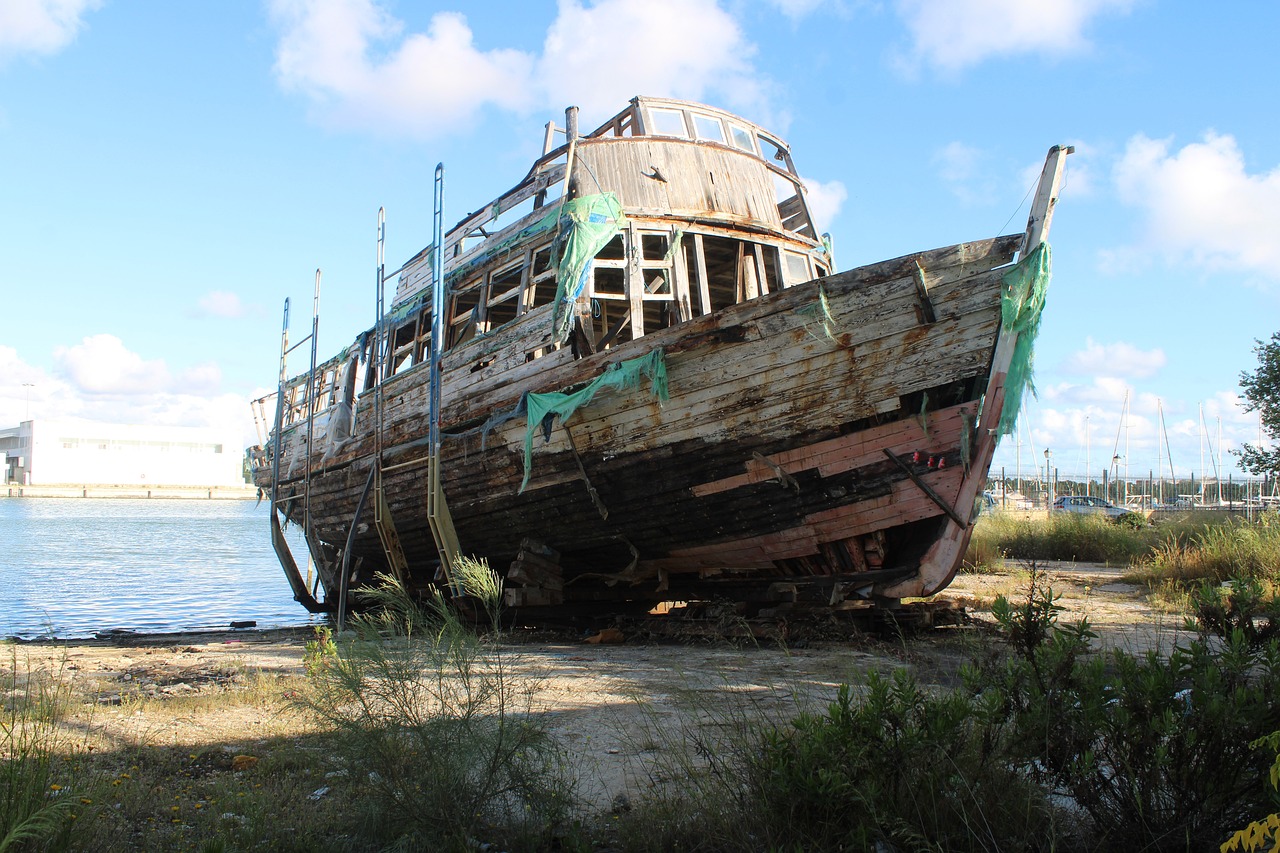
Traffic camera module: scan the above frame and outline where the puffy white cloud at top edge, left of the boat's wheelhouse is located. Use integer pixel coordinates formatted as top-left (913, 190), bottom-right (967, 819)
top-left (271, 0), bottom-right (532, 137)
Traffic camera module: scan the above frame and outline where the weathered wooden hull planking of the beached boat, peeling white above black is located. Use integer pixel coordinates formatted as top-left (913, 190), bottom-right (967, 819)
top-left (267, 238), bottom-right (1019, 594)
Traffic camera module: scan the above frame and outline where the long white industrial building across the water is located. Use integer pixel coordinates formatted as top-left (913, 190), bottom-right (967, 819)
top-left (0, 419), bottom-right (244, 487)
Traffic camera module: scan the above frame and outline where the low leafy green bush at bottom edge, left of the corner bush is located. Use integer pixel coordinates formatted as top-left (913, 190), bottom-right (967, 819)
top-left (744, 670), bottom-right (1053, 850)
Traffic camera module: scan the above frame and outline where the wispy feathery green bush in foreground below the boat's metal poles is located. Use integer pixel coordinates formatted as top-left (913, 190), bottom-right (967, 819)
top-left (308, 560), bottom-right (573, 849)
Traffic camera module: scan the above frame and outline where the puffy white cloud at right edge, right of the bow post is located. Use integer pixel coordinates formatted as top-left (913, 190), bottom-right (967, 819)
top-left (1105, 132), bottom-right (1280, 279)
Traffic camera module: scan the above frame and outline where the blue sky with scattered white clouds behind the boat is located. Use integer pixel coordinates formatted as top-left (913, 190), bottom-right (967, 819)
top-left (0, 0), bottom-right (1280, 476)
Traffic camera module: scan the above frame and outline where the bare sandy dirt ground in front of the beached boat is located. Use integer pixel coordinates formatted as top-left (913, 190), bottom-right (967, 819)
top-left (0, 564), bottom-right (1189, 806)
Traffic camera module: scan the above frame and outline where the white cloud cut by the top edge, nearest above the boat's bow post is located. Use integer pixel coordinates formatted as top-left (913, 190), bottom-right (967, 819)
top-left (896, 0), bottom-right (1134, 72)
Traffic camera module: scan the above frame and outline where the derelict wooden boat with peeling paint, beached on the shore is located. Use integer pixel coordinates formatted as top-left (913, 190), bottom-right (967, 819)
top-left (255, 97), bottom-right (1070, 612)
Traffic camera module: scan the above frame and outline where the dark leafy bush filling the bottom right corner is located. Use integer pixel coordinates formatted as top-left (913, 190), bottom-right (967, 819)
top-left (966, 560), bottom-right (1280, 850)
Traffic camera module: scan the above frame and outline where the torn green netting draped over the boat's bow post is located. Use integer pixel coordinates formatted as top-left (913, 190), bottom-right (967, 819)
top-left (997, 242), bottom-right (1052, 435)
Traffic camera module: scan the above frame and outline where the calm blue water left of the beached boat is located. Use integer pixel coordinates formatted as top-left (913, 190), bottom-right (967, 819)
top-left (0, 498), bottom-right (314, 638)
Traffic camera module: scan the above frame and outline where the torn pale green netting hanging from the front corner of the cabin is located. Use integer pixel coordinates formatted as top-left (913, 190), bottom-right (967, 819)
top-left (552, 192), bottom-right (626, 342)
